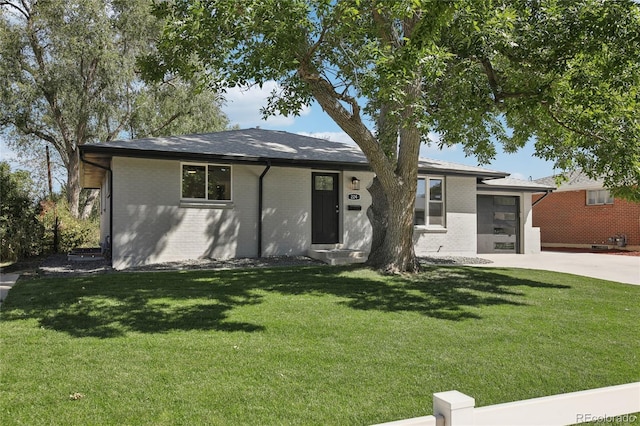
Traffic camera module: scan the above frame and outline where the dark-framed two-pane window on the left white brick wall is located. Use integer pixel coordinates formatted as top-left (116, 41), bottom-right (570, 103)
top-left (181, 164), bottom-right (231, 201)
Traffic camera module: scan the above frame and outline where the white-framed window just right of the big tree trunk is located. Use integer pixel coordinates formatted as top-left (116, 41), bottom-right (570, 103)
top-left (413, 177), bottom-right (445, 228)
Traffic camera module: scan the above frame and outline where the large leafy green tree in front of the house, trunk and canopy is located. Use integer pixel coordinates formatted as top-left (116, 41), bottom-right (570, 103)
top-left (143, 0), bottom-right (640, 272)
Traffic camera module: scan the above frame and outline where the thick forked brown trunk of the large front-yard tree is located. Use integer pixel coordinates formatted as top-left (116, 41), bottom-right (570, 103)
top-left (299, 63), bottom-right (421, 274)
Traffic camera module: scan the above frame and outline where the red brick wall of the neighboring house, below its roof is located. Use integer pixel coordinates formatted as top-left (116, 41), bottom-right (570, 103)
top-left (533, 190), bottom-right (640, 247)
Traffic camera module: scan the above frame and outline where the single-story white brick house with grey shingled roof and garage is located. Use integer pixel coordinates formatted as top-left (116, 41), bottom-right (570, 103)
top-left (80, 129), bottom-right (550, 269)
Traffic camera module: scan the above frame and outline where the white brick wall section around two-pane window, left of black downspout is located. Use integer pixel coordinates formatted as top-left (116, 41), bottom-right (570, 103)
top-left (112, 157), bottom-right (263, 269)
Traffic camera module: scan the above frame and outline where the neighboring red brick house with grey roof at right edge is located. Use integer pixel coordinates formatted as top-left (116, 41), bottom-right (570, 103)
top-left (532, 172), bottom-right (640, 251)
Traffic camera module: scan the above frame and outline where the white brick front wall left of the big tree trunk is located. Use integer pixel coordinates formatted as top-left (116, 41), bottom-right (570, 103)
top-left (112, 157), bottom-right (372, 269)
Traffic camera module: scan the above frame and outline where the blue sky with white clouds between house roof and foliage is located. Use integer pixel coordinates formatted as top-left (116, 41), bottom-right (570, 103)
top-left (228, 83), bottom-right (555, 180)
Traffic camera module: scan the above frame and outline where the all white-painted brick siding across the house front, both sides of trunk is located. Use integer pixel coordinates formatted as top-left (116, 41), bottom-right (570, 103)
top-left (107, 157), bottom-right (539, 269)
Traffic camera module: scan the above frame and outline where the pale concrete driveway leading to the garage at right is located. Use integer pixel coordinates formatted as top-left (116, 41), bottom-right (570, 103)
top-left (474, 251), bottom-right (640, 285)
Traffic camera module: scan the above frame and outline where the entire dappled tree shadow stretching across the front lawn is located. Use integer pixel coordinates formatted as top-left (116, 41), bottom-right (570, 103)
top-left (2, 266), bottom-right (570, 338)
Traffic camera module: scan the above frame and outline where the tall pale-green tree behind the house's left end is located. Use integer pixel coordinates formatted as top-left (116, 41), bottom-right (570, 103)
top-left (0, 0), bottom-right (227, 216)
